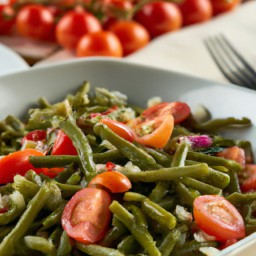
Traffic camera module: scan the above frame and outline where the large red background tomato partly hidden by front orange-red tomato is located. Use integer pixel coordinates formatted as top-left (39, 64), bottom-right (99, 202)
top-left (56, 9), bottom-right (102, 49)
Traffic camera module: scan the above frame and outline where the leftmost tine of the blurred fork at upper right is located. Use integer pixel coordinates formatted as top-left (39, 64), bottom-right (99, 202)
top-left (204, 38), bottom-right (252, 87)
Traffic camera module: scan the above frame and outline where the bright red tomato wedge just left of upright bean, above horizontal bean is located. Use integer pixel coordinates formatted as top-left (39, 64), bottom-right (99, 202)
top-left (51, 130), bottom-right (77, 155)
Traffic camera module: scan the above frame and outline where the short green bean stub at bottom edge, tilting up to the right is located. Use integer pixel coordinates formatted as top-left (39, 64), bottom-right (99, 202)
top-left (159, 229), bottom-right (181, 256)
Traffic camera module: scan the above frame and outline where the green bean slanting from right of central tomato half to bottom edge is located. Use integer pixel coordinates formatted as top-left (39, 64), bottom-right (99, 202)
top-left (109, 201), bottom-right (161, 256)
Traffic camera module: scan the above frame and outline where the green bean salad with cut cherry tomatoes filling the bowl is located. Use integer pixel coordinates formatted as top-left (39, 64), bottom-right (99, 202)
top-left (0, 82), bottom-right (256, 256)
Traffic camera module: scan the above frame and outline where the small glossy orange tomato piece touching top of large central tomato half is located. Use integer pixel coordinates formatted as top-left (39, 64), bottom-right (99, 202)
top-left (88, 171), bottom-right (132, 193)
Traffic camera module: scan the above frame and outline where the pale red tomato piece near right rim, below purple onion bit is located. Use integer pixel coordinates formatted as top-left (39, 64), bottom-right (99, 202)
top-left (216, 146), bottom-right (245, 167)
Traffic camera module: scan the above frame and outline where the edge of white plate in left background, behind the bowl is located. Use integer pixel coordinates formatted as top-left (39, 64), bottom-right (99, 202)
top-left (0, 43), bottom-right (29, 76)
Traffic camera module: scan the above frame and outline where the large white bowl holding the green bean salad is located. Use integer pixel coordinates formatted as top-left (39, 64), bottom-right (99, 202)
top-left (0, 58), bottom-right (256, 256)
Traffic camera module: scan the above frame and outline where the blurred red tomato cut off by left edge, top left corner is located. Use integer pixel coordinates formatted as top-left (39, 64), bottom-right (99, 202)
top-left (0, 5), bottom-right (15, 35)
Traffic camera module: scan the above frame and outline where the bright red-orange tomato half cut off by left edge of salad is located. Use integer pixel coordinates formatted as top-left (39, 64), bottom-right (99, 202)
top-left (0, 148), bottom-right (46, 184)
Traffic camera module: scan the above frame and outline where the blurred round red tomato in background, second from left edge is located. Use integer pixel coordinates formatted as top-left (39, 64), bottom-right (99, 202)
top-left (16, 4), bottom-right (55, 40)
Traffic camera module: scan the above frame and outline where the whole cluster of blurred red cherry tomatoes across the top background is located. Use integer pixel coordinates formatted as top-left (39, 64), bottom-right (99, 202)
top-left (0, 0), bottom-right (240, 57)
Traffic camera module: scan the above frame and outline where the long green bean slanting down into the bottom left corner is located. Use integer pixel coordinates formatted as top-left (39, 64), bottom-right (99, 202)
top-left (0, 182), bottom-right (52, 256)
